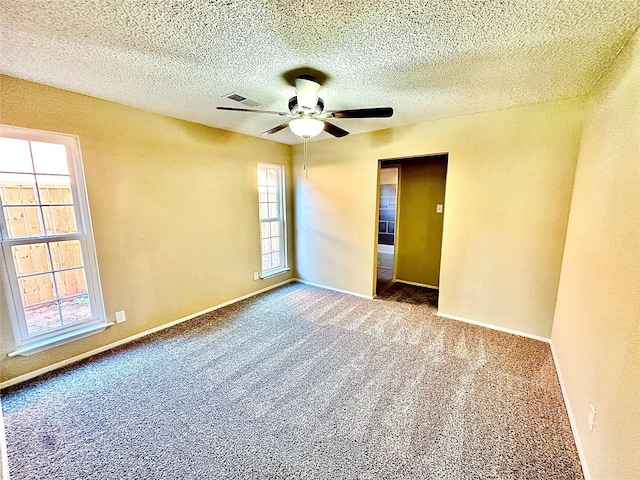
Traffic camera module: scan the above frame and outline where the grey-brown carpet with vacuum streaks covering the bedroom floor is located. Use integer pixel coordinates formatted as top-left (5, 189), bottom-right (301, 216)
top-left (2, 284), bottom-right (583, 480)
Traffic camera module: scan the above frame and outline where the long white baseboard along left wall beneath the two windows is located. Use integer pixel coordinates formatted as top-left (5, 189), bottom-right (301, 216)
top-left (0, 278), bottom-right (296, 390)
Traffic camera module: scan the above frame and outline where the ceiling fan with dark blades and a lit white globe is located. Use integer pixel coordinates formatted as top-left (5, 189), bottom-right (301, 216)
top-left (217, 75), bottom-right (393, 139)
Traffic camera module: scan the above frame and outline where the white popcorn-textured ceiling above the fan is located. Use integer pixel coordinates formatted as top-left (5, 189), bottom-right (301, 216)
top-left (0, 0), bottom-right (640, 144)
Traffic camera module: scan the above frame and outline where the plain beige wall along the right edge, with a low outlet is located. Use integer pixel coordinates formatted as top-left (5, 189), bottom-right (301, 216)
top-left (552, 27), bottom-right (640, 480)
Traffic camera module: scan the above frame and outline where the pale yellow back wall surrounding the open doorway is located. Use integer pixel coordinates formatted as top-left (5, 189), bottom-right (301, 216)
top-left (294, 98), bottom-right (586, 337)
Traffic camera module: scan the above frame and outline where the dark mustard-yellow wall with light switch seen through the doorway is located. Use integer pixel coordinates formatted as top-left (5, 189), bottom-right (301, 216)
top-left (396, 156), bottom-right (447, 287)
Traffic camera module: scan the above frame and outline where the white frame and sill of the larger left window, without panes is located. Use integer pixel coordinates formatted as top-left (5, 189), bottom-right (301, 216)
top-left (0, 125), bottom-right (113, 357)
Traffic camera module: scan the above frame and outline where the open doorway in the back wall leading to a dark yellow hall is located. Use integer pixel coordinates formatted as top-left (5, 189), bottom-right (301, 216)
top-left (376, 154), bottom-right (448, 294)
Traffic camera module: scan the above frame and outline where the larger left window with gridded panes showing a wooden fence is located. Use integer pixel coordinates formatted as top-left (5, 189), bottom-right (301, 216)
top-left (0, 126), bottom-right (105, 348)
